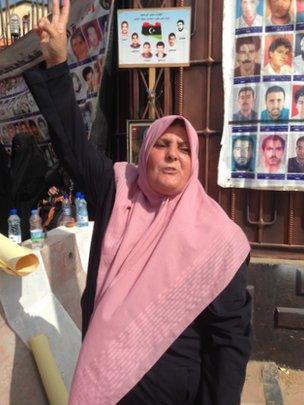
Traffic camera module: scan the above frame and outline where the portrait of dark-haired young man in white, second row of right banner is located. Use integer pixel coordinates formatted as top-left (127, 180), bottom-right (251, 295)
top-left (262, 36), bottom-right (292, 75)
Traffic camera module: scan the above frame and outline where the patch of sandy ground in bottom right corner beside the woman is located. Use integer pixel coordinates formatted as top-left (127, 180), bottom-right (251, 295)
top-left (241, 360), bottom-right (304, 405)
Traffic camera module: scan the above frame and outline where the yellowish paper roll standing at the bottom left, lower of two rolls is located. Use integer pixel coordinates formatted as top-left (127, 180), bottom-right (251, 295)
top-left (29, 335), bottom-right (68, 405)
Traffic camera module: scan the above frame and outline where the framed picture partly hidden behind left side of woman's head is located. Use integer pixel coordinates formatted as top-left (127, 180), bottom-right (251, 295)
top-left (127, 120), bottom-right (153, 164)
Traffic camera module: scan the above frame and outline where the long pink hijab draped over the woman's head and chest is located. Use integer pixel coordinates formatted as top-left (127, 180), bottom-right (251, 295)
top-left (69, 115), bottom-right (249, 405)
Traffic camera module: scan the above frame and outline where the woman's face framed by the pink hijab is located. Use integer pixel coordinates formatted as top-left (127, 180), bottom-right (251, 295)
top-left (147, 124), bottom-right (191, 196)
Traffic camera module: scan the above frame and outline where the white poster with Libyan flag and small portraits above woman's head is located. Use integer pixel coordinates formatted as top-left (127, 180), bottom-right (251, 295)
top-left (117, 7), bottom-right (191, 68)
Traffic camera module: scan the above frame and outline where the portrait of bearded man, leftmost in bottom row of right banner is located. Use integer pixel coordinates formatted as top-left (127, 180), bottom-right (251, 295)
top-left (231, 135), bottom-right (255, 172)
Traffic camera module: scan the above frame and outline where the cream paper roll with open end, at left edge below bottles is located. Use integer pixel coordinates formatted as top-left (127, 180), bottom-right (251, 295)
top-left (0, 233), bottom-right (39, 276)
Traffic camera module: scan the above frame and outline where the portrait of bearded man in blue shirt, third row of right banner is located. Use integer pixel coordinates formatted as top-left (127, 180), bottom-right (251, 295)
top-left (261, 86), bottom-right (289, 121)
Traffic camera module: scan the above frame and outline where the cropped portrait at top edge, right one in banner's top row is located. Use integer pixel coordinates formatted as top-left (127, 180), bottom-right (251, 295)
top-left (265, 0), bottom-right (293, 26)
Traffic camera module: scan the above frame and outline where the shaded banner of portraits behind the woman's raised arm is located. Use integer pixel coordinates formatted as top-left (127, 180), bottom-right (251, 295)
top-left (0, 0), bottom-right (112, 167)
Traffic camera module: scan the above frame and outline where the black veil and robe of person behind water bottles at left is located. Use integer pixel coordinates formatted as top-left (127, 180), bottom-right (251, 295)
top-left (11, 133), bottom-right (48, 240)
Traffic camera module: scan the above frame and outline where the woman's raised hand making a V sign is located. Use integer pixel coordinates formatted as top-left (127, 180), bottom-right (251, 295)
top-left (35, 0), bottom-right (70, 68)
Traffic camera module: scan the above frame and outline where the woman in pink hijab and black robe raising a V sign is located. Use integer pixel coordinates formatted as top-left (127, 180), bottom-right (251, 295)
top-left (25, 0), bottom-right (251, 405)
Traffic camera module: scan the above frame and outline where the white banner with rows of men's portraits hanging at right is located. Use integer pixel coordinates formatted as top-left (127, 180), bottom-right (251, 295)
top-left (218, 0), bottom-right (304, 190)
